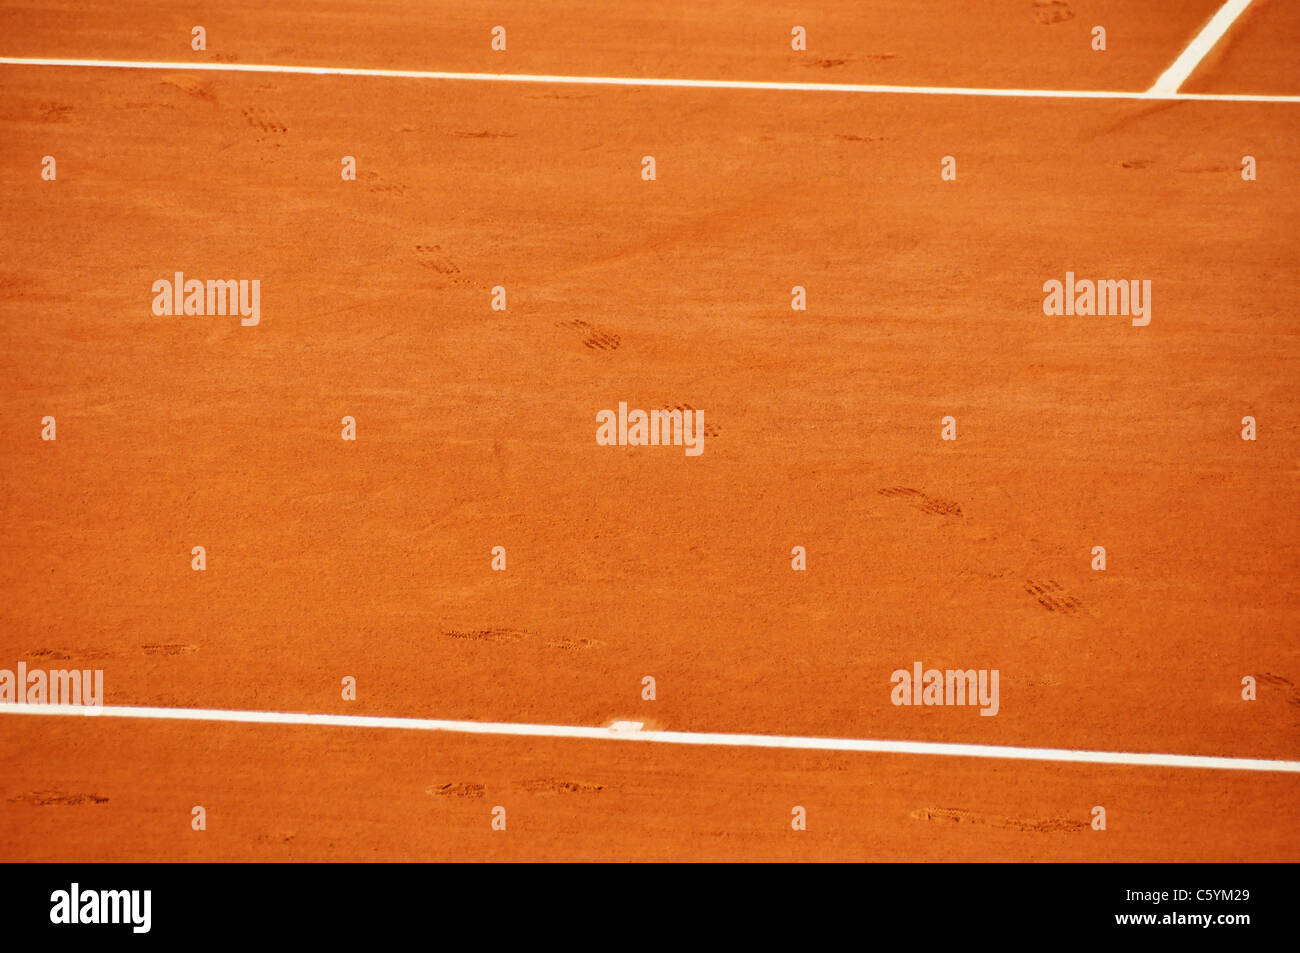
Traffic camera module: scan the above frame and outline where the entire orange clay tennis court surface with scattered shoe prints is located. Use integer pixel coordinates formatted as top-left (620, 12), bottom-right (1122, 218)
top-left (0, 0), bottom-right (1300, 861)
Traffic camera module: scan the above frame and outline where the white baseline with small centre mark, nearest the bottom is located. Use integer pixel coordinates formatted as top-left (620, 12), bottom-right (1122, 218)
top-left (0, 702), bottom-right (1300, 774)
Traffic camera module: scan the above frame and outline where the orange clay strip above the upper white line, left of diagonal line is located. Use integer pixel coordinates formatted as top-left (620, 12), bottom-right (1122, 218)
top-left (0, 0), bottom-right (1227, 89)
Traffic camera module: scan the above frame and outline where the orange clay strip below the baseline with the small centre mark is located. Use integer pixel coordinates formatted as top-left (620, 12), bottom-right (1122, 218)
top-left (10, 718), bottom-right (1296, 861)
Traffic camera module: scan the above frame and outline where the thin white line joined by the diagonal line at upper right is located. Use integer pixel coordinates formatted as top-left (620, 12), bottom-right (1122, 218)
top-left (0, 56), bottom-right (1300, 103)
